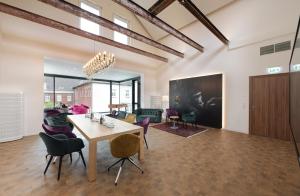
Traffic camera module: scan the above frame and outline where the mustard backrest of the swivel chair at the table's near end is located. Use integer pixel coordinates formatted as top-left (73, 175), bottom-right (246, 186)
top-left (110, 134), bottom-right (140, 158)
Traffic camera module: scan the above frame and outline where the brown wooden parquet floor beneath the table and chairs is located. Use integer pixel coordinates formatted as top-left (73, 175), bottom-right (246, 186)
top-left (0, 128), bottom-right (300, 196)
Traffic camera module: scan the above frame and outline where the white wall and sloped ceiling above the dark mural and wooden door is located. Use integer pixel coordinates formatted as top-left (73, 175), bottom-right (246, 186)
top-left (157, 0), bottom-right (300, 133)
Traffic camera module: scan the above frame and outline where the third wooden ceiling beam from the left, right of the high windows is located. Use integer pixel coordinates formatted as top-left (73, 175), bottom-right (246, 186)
top-left (112, 0), bottom-right (204, 52)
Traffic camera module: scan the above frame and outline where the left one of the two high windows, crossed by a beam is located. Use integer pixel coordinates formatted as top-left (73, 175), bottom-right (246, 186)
top-left (80, 1), bottom-right (100, 35)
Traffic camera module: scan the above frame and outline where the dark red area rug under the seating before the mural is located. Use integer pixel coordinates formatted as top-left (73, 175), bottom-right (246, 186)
top-left (152, 123), bottom-right (207, 137)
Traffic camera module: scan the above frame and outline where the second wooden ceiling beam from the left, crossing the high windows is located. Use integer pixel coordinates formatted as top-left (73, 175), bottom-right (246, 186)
top-left (39, 0), bottom-right (184, 58)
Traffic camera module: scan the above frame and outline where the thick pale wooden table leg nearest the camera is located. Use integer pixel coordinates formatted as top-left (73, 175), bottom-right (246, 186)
top-left (88, 141), bottom-right (97, 182)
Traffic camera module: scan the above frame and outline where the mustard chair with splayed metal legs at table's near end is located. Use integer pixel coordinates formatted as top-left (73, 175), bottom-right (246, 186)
top-left (107, 134), bottom-right (144, 185)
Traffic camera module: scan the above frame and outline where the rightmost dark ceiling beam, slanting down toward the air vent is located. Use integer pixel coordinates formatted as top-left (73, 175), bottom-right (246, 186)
top-left (178, 0), bottom-right (229, 45)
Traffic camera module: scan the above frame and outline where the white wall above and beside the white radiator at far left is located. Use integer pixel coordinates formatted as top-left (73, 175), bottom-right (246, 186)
top-left (0, 45), bottom-right (43, 135)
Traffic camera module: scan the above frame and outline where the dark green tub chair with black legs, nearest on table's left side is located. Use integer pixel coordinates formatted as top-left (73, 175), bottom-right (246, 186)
top-left (39, 132), bottom-right (86, 180)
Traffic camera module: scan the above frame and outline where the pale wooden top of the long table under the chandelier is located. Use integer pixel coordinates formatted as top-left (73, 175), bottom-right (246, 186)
top-left (67, 114), bottom-right (142, 141)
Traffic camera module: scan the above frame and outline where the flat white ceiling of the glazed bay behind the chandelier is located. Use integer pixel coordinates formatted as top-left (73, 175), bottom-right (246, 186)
top-left (44, 57), bottom-right (140, 81)
